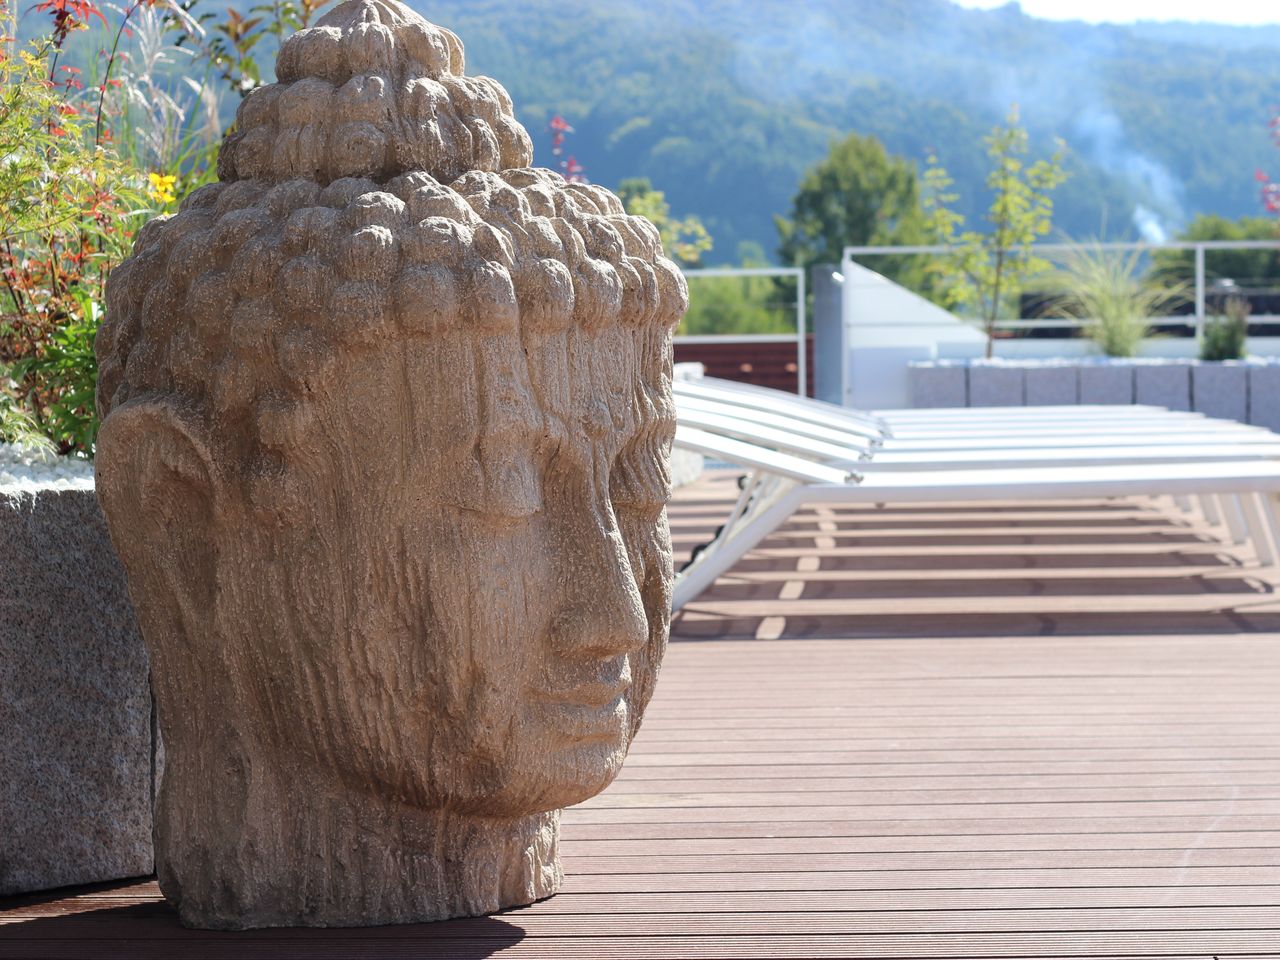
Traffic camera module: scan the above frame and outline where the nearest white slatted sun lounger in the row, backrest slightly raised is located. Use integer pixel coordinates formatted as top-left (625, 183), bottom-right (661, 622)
top-left (673, 424), bottom-right (1280, 609)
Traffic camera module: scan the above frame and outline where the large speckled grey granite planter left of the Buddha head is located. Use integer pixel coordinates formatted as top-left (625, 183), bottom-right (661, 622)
top-left (0, 488), bottom-right (152, 895)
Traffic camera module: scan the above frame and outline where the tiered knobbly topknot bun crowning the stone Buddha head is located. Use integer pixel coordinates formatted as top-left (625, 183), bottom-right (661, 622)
top-left (218, 0), bottom-right (532, 184)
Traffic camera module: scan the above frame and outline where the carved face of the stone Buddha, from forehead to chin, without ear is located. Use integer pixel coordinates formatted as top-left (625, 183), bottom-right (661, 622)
top-left (218, 313), bottom-right (671, 815)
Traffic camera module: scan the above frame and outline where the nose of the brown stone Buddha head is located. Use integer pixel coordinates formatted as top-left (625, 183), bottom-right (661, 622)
top-left (554, 517), bottom-right (649, 659)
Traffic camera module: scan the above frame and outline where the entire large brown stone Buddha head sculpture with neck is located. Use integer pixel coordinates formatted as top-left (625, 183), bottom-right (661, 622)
top-left (97, 0), bottom-right (687, 928)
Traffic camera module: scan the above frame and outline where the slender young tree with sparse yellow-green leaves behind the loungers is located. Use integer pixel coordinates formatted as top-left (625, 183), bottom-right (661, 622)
top-left (924, 108), bottom-right (1065, 357)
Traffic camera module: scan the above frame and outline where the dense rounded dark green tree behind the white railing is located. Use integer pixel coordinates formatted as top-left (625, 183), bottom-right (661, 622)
top-left (773, 133), bottom-right (928, 289)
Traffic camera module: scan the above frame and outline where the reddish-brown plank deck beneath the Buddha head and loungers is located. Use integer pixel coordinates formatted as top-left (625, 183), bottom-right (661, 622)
top-left (0, 475), bottom-right (1280, 960)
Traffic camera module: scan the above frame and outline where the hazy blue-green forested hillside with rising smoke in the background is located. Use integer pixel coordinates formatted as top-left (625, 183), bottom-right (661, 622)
top-left (411, 0), bottom-right (1280, 262)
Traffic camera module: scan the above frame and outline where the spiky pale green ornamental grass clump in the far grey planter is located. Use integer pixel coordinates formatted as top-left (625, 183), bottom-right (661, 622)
top-left (1050, 242), bottom-right (1187, 357)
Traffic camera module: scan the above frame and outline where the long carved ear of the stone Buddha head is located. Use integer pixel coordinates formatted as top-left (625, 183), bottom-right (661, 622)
top-left (95, 398), bottom-right (218, 655)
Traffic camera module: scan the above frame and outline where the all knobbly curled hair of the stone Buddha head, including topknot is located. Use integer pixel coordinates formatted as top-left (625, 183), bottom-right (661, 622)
top-left (97, 0), bottom-right (687, 455)
